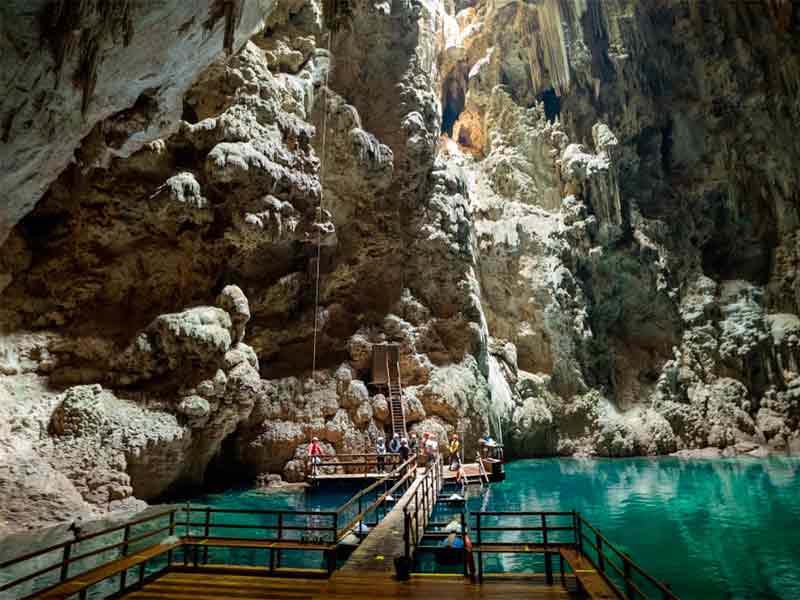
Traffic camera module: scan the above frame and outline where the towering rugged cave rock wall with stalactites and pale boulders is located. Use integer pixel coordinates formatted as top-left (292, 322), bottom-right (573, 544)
top-left (0, 0), bottom-right (800, 531)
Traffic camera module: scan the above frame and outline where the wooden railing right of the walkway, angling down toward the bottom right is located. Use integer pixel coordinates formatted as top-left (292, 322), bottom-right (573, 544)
top-left (473, 511), bottom-right (677, 600)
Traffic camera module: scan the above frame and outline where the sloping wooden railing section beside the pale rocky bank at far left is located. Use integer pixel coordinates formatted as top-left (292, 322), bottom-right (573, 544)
top-left (0, 508), bottom-right (178, 597)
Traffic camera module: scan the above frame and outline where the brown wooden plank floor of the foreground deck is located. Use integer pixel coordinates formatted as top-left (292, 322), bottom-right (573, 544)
top-left (122, 572), bottom-right (571, 600)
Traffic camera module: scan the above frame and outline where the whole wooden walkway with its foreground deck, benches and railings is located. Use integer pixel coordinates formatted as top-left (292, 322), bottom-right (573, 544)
top-left (0, 458), bottom-right (677, 600)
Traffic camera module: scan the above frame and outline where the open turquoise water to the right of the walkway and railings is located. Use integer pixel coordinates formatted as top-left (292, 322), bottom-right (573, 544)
top-left (488, 458), bottom-right (800, 599)
